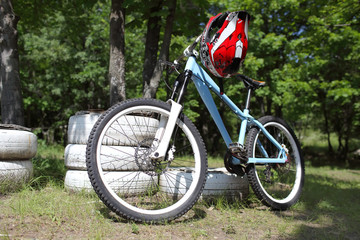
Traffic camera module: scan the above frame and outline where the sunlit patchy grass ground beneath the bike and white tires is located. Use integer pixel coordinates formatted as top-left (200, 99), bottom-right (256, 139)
top-left (0, 144), bottom-right (360, 239)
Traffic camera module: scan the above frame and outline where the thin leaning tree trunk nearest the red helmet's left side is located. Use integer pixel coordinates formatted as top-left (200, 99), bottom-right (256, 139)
top-left (144, 0), bottom-right (176, 98)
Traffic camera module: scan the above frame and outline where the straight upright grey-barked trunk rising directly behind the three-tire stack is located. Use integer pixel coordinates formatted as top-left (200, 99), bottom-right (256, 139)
top-left (109, 0), bottom-right (126, 106)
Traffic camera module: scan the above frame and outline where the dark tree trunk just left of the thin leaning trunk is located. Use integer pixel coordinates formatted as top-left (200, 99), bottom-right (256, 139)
top-left (143, 0), bottom-right (162, 98)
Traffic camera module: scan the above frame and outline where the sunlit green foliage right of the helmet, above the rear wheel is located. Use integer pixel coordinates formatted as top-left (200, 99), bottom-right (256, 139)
top-left (211, 0), bottom-right (360, 159)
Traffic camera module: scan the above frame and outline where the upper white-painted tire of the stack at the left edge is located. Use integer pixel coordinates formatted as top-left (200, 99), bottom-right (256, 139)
top-left (0, 129), bottom-right (37, 160)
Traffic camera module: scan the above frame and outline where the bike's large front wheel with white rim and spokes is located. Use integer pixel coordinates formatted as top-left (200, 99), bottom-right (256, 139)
top-left (86, 99), bottom-right (207, 222)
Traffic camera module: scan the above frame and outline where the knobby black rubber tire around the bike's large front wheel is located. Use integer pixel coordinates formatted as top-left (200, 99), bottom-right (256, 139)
top-left (86, 98), bottom-right (207, 223)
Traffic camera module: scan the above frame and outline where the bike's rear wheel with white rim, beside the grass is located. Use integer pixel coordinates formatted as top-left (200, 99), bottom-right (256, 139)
top-left (246, 116), bottom-right (305, 210)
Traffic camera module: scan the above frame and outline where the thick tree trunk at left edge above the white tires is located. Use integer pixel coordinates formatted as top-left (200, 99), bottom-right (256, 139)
top-left (0, 0), bottom-right (24, 125)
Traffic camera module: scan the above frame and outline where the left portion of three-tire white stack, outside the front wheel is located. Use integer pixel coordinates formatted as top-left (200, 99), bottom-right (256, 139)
top-left (65, 111), bottom-right (101, 191)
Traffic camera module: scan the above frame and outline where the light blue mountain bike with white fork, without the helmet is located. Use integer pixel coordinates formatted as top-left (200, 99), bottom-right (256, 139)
top-left (86, 37), bottom-right (305, 222)
